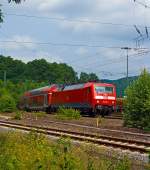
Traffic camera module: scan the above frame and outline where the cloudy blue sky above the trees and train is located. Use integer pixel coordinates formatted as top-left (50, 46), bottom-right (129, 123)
top-left (0, 0), bottom-right (150, 79)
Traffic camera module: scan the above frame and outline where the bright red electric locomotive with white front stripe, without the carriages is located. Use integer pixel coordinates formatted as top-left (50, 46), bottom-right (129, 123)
top-left (51, 82), bottom-right (116, 115)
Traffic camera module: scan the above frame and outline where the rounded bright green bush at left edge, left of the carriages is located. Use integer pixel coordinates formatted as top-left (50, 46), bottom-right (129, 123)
top-left (0, 94), bottom-right (16, 112)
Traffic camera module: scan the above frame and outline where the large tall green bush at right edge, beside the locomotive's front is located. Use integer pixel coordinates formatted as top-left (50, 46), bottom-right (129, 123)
top-left (123, 69), bottom-right (150, 129)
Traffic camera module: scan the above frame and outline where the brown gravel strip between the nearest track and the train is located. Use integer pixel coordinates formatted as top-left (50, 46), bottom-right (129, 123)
top-left (0, 113), bottom-right (150, 141)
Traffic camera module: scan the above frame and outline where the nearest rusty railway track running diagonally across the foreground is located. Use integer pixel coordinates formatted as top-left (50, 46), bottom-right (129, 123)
top-left (0, 121), bottom-right (150, 153)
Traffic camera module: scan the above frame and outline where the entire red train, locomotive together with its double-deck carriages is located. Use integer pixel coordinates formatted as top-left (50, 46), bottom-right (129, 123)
top-left (18, 82), bottom-right (116, 116)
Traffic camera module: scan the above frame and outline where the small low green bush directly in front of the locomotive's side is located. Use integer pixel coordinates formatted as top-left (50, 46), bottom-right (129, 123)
top-left (56, 107), bottom-right (81, 119)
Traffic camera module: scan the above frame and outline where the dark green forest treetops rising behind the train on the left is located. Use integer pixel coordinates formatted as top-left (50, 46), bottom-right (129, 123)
top-left (0, 55), bottom-right (98, 83)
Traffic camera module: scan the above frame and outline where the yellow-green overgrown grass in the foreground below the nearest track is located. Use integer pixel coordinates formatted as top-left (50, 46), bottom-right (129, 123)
top-left (0, 132), bottom-right (138, 170)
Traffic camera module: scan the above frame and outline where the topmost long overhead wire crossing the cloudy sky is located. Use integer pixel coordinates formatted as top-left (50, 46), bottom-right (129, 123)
top-left (4, 13), bottom-right (150, 28)
